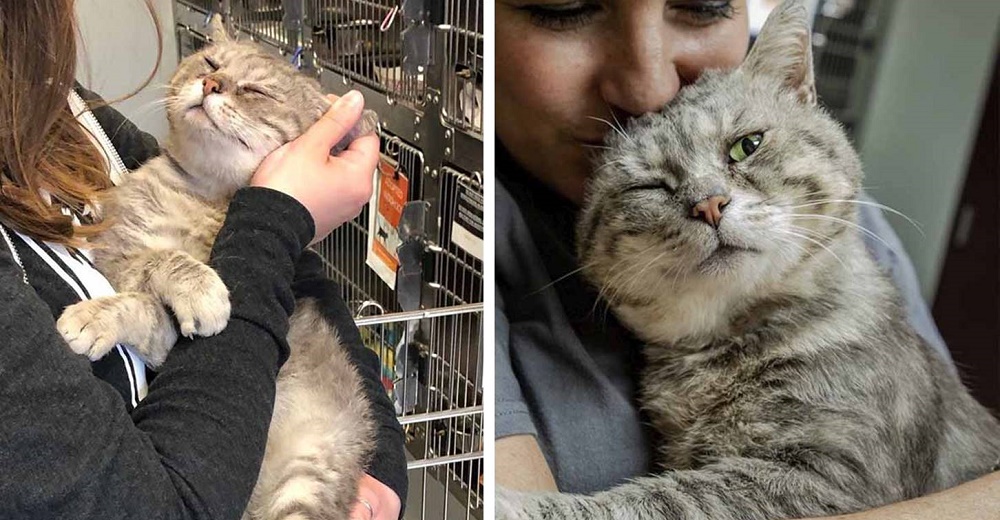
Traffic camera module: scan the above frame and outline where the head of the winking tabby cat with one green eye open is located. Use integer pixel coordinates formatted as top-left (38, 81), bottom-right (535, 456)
top-left (577, 1), bottom-right (862, 340)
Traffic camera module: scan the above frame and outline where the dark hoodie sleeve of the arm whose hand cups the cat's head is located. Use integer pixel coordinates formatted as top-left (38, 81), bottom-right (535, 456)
top-left (0, 188), bottom-right (314, 519)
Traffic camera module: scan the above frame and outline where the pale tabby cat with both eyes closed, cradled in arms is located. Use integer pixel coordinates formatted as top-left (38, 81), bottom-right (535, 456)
top-left (57, 17), bottom-right (377, 520)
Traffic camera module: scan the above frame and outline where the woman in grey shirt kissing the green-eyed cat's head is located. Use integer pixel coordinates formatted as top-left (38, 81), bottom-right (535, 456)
top-left (495, 0), bottom-right (1000, 519)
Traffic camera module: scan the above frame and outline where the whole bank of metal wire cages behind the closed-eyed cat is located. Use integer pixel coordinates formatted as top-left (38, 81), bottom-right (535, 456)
top-left (174, 0), bottom-right (484, 519)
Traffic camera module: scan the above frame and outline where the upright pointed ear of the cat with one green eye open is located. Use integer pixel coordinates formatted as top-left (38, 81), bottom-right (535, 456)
top-left (742, 0), bottom-right (816, 104)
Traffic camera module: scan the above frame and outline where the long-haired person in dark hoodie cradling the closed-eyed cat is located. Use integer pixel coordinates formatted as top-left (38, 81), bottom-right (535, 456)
top-left (0, 0), bottom-right (406, 520)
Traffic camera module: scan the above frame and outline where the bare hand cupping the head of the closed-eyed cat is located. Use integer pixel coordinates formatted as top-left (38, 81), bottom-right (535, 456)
top-left (250, 91), bottom-right (379, 243)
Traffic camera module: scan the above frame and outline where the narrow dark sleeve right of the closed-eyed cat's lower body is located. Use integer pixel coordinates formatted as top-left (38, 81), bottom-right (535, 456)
top-left (292, 250), bottom-right (407, 510)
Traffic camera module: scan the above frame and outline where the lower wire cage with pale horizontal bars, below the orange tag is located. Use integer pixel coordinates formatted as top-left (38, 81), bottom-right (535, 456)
top-left (357, 303), bottom-right (483, 519)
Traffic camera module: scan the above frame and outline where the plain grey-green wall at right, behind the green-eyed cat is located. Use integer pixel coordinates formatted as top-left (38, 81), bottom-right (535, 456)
top-left (858, 0), bottom-right (1000, 300)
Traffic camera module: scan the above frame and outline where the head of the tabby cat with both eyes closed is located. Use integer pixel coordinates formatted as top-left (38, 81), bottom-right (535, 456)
top-left (166, 15), bottom-right (378, 191)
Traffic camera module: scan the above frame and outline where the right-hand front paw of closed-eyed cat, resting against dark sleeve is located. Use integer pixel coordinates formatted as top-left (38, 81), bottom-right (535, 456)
top-left (171, 266), bottom-right (230, 338)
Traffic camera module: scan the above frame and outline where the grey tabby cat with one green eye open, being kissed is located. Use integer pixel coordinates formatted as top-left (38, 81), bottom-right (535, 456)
top-left (498, 1), bottom-right (1000, 520)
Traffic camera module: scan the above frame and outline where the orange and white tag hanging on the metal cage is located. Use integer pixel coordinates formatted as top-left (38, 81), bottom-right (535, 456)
top-left (368, 155), bottom-right (410, 288)
